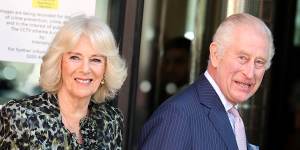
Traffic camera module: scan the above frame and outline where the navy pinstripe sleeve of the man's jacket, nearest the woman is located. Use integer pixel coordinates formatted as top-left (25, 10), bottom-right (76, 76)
top-left (138, 106), bottom-right (192, 150)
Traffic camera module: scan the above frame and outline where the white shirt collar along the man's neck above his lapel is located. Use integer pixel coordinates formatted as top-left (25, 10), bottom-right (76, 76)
top-left (204, 70), bottom-right (233, 111)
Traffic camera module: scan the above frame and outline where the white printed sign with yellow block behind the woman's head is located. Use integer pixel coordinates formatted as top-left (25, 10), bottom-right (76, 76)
top-left (0, 0), bottom-right (96, 63)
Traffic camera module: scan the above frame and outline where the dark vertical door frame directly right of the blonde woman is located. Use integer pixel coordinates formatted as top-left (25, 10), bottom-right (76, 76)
top-left (110, 0), bottom-right (144, 150)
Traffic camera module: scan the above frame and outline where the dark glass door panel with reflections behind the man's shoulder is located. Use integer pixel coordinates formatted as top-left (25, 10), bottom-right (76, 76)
top-left (133, 0), bottom-right (205, 148)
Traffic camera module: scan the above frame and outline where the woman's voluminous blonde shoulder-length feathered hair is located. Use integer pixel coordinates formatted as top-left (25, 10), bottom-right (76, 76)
top-left (40, 15), bottom-right (127, 103)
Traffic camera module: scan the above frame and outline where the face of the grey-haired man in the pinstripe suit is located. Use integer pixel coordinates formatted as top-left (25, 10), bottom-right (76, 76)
top-left (214, 27), bottom-right (268, 105)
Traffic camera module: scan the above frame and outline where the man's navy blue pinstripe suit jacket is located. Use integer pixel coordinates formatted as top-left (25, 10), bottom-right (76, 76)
top-left (138, 75), bottom-right (246, 150)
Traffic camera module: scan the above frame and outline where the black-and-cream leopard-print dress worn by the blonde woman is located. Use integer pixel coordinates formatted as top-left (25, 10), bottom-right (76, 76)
top-left (0, 92), bottom-right (123, 150)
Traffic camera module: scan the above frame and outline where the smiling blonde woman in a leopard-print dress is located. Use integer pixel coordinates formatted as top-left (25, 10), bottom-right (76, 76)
top-left (0, 16), bottom-right (127, 149)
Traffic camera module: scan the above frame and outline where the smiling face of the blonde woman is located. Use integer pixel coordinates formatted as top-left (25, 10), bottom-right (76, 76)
top-left (60, 35), bottom-right (106, 99)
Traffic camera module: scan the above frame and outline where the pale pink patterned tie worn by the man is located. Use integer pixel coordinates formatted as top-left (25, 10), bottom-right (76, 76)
top-left (229, 107), bottom-right (247, 150)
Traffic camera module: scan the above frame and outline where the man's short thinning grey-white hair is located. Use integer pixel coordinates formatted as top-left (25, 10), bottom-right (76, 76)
top-left (213, 13), bottom-right (275, 69)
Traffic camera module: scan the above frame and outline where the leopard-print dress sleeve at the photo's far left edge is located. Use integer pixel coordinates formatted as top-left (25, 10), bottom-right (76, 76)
top-left (0, 102), bottom-right (30, 149)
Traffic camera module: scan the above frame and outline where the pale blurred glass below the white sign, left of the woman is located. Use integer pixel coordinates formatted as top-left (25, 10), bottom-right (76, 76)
top-left (0, 61), bottom-right (40, 104)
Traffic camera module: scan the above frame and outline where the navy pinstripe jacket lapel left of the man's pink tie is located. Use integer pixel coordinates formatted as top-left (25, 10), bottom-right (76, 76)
top-left (196, 75), bottom-right (238, 150)
